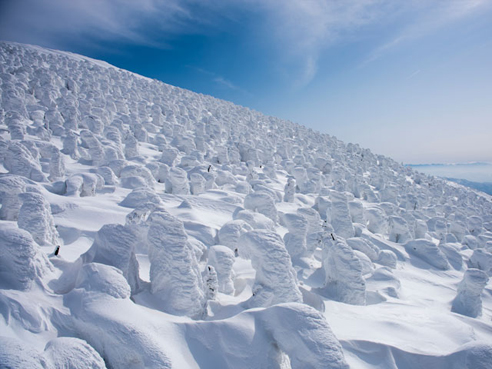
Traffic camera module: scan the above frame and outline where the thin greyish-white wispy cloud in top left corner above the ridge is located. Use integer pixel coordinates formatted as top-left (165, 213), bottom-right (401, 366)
top-left (0, 0), bottom-right (213, 47)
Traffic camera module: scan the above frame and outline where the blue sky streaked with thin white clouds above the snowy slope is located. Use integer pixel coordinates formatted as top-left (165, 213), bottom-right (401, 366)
top-left (0, 0), bottom-right (492, 163)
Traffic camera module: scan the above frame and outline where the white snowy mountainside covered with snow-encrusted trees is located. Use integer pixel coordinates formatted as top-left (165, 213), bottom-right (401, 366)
top-left (0, 43), bottom-right (492, 369)
